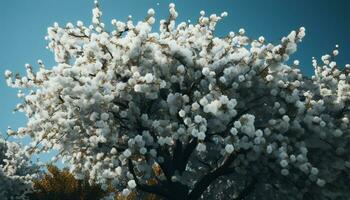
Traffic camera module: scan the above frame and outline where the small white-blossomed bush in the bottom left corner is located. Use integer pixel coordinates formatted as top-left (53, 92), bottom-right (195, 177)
top-left (0, 137), bottom-right (38, 200)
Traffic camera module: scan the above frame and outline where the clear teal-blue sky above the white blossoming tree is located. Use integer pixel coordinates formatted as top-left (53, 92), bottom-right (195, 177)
top-left (0, 0), bottom-right (350, 165)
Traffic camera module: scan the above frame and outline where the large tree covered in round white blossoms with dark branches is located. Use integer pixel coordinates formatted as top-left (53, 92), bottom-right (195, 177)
top-left (5, 2), bottom-right (350, 200)
